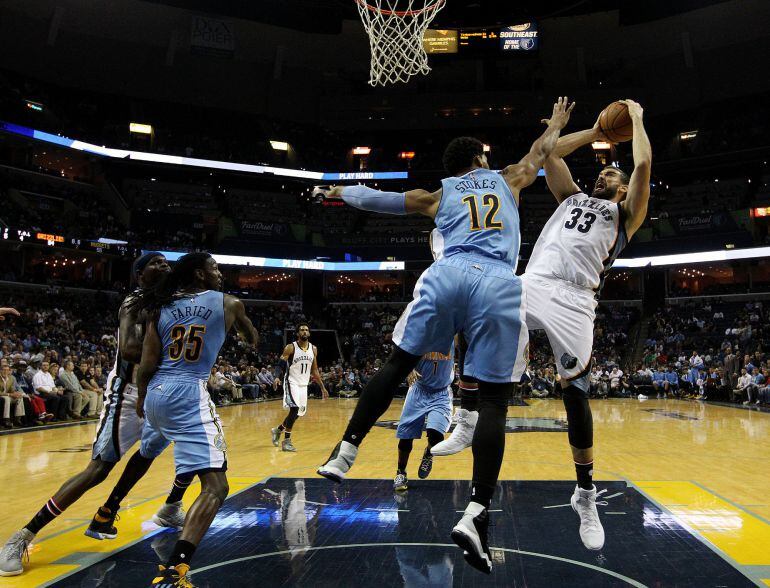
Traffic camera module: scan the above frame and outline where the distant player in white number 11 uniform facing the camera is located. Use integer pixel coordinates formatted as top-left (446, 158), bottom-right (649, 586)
top-left (270, 323), bottom-right (329, 451)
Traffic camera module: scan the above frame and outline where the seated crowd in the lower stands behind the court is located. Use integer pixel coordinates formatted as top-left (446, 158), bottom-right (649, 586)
top-left (0, 282), bottom-right (770, 428)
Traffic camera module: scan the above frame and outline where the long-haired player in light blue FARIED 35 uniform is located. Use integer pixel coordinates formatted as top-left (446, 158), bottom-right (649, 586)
top-left (127, 253), bottom-right (257, 587)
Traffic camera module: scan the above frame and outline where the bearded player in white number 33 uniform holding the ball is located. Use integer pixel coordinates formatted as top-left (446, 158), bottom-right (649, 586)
top-left (433, 100), bottom-right (652, 550)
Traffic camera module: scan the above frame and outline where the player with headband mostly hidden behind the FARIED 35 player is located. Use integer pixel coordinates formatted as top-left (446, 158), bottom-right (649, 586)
top-left (0, 251), bottom-right (192, 576)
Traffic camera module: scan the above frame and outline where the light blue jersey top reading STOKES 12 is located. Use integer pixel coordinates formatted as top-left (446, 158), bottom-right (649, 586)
top-left (432, 168), bottom-right (521, 268)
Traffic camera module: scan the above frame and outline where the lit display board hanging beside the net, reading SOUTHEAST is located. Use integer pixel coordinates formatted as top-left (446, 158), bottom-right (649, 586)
top-left (423, 22), bottom-right (540, 56)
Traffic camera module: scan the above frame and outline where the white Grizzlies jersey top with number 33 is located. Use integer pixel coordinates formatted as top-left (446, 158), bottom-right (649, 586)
top-left (526, 192), bottom-right (628, 295)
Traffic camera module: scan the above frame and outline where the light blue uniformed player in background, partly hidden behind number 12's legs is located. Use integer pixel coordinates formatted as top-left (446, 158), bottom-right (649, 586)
top-left (393, 343), bottom-right (455, 492)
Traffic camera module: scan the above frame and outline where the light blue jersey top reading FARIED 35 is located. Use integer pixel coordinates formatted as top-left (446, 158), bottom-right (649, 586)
top-left (154, 290), bottom-right (226, 380)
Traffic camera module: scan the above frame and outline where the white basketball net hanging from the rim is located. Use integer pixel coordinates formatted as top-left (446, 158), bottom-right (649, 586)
top-left (355, 0), bottom-right (446, 86)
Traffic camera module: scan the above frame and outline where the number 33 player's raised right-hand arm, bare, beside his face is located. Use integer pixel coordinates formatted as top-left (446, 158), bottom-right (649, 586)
top-left (621, 100), bottom-right (652, 239)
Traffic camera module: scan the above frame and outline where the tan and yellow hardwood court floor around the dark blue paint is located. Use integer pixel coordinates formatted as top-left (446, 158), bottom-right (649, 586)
top-left (0, 399), bottom-right (770, 586)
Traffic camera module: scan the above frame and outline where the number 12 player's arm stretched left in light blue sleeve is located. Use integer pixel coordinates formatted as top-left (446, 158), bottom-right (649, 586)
top-left (316, 186), bottom-right (441, 218)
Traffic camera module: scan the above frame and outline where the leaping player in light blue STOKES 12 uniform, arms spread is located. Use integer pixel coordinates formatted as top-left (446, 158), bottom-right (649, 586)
top-left (316, 98), bottom-right (574, 573)
